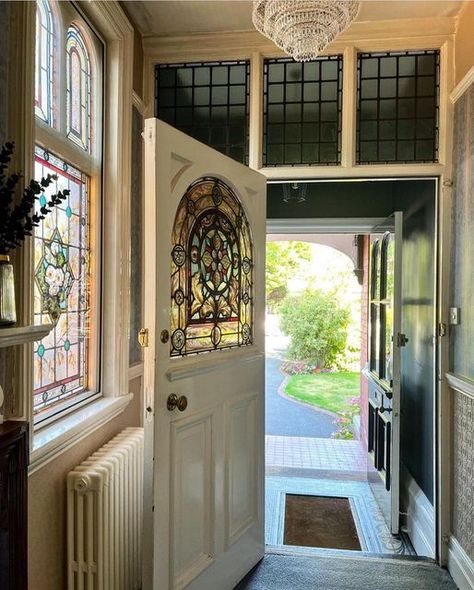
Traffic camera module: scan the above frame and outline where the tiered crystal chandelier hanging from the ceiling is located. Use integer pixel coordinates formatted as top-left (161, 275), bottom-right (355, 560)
top-left (252, 0), bottom-right (360, 61)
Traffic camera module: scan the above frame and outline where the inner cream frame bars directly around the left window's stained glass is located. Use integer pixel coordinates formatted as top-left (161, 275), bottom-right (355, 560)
top-left (32, 0), bottom-right (105, 430)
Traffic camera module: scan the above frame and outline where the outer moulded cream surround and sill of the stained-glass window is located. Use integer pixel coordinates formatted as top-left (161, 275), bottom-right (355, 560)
top-left (13, 2), bottom-right (134, 472)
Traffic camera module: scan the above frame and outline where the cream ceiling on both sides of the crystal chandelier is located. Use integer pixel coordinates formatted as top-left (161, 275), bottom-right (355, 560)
top-left (123, 0), bottom-right (463, 37)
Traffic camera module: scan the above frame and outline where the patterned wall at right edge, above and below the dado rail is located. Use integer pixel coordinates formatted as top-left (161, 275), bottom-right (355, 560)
top-left (451, 81), bottom-right (474, 561)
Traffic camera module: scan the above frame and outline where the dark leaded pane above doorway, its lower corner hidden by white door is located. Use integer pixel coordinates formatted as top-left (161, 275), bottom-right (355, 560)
top-left (155, 61), bottom-right (249, 164)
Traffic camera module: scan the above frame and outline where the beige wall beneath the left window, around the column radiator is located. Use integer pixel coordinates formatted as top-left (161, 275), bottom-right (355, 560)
top-left (28, 378), bottom-right (142, 590)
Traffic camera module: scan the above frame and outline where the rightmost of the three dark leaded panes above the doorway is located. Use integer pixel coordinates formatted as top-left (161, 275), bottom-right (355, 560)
top-left (357, 50), bottom-right (439, 164)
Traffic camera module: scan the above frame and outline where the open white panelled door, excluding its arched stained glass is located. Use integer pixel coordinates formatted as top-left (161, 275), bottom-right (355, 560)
top-left (143, 119), bottom-right (266, 590)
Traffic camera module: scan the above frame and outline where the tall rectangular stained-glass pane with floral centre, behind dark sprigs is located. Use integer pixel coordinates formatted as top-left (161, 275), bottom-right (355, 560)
top-left (33, 147), bottom-right (90, 413)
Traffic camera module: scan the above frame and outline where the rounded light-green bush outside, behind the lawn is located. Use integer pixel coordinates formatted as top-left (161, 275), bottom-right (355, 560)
top-left (280, 288), bottom-right (350, 369)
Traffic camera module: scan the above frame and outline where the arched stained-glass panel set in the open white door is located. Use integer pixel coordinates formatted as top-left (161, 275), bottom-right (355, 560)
top-left (171, 178), bottom-right (253, 356)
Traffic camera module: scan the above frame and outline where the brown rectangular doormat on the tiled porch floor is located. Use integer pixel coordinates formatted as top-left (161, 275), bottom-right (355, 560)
top-left (283, 494), bottom-right (362, 551)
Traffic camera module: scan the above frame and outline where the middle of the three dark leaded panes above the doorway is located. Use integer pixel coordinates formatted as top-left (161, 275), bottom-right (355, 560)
top-left (263, 55), bottom-right (342, 166)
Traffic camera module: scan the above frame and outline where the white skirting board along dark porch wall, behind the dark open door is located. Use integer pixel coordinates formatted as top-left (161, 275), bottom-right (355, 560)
top-left (400, 465), bottom-right (436, 559)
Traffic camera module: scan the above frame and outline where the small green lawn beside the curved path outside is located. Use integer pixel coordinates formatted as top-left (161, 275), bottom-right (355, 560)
top-left (285, 372), bottom-right (360, 414)
